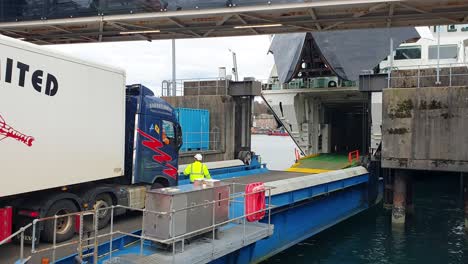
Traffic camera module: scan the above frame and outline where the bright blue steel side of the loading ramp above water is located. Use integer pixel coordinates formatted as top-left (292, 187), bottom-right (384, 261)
top-left (216, 171), bottom-right (383, 264)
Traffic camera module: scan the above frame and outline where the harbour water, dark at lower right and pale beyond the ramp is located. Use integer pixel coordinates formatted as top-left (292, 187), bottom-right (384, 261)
top-left (252, 136), bottom-right (468, 264)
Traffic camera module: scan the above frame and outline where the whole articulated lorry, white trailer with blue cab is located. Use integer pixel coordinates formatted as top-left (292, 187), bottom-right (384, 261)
top-left (0, 36), bottom-right (182, 241)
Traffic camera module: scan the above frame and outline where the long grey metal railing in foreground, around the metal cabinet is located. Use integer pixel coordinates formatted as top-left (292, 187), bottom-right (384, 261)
top-left (0, 183), bottom-right (274, 264)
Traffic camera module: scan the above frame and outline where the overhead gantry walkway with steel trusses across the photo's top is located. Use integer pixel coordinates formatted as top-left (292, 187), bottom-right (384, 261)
top-left (0, 0), bottom-right (468, 44)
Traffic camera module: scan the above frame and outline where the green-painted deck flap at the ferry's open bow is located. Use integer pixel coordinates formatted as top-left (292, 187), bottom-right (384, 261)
top-left (295, 154), bottom-right (352, 170)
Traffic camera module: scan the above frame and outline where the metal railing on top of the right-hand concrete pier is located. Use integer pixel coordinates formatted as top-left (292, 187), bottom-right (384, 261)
top-left (381, 63), bottom-right (468, 88)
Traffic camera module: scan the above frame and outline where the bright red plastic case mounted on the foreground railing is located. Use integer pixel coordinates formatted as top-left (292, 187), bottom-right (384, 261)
top-left (245, 182), bottom-right (266, 222)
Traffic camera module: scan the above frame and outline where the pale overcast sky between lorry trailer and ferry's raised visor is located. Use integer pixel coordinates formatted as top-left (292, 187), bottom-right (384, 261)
top-left (51, 36), bottom-right (273, 94)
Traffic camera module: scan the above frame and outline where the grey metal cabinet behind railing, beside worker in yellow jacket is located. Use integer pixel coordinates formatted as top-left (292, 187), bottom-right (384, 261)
top-left (143, 182), bottom-right (230, 240)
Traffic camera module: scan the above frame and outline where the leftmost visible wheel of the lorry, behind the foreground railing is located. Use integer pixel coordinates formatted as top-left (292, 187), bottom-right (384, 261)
top-left (42, 200), bottom-right (78, 242)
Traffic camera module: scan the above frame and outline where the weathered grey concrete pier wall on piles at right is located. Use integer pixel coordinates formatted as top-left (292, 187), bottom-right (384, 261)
top-left (382, 86), bottom-right (468, 172)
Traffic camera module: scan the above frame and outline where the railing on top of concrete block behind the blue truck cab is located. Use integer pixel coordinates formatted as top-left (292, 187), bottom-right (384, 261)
top-left (161, 77), bottom-right (229, 96)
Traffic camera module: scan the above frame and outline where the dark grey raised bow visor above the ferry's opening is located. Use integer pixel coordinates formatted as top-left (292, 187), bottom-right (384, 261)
top-left (270, 27), bottom-right (420, 83)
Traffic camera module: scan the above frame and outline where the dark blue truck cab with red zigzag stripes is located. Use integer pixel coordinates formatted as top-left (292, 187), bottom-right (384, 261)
top-left (125, 84), bottom-right (182, 188)
